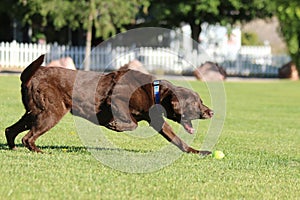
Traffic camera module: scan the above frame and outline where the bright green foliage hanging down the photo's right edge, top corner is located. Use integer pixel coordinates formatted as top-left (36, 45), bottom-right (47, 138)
top-left (276, 0), bottom-right (300, 72)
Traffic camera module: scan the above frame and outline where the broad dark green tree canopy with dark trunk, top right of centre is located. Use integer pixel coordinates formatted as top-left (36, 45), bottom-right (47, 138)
top-left (143, 0), bottom-right (273, 41)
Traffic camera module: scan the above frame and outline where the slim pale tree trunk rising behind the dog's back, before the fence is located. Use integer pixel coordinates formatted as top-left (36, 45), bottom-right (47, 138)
top-left (84, 10), bottom-right (93, 71)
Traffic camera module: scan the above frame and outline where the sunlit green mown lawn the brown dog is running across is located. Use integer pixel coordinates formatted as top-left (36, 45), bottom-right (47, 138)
top-left (0, 76), bottom-right (300, 200)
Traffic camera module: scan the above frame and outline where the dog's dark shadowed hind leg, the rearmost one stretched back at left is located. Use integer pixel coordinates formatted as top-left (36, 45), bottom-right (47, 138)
top-left (5, 113), bottom-right (32, 150)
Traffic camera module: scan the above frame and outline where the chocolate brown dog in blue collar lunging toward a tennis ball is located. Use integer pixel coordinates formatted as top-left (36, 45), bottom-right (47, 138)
top-left (5, 55), bottom-right (213, 155)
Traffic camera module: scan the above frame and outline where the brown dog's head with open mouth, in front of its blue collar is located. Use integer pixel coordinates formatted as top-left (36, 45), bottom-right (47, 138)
top-left (163, 87), bottom-right (214, 134)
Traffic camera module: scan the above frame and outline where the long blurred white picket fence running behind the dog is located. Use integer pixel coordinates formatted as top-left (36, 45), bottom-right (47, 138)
top-left (0, 42), bottom-right (290, 76)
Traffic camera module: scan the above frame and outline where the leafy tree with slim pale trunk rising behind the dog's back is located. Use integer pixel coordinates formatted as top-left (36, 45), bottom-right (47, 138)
top-left (20, 0), bottom-right (148, 70)
